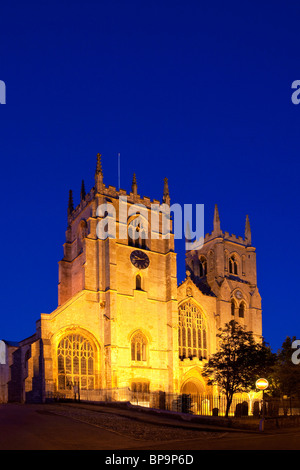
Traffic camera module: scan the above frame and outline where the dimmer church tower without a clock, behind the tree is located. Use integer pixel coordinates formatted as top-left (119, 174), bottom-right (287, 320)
top-left (186, 205), bottom-right (262, 340)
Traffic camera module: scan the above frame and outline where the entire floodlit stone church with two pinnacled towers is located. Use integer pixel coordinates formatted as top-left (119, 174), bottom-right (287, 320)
top-left (0, 154), bottom-right (262, 402)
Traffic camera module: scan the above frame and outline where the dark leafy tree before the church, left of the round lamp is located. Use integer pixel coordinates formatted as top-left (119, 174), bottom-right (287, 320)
top-left (202, 320), bottom-right (274, 416)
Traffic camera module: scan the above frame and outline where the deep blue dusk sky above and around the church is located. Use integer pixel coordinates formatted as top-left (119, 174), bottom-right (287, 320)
top-left (0, 0), bottom-right (300, 350)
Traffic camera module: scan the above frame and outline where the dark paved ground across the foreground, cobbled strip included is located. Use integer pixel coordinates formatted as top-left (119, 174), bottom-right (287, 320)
top-left (0, 403), bottom-right (300, 452)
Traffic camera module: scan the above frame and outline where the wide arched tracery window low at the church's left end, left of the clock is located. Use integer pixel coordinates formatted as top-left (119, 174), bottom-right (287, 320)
top-left (57, 334), bottom-right (95, 390)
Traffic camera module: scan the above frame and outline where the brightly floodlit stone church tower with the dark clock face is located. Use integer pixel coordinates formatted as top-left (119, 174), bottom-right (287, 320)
top-left (41, 154), bottom-right (178, 393)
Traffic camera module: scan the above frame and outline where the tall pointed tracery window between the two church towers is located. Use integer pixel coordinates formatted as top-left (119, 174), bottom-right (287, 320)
top-left (178, 301), bottom-right (207, 359)
